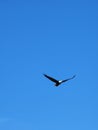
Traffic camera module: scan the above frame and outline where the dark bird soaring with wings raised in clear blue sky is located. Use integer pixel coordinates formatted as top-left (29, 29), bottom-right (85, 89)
top-left (43, 74), bottom-right (76, 87)
